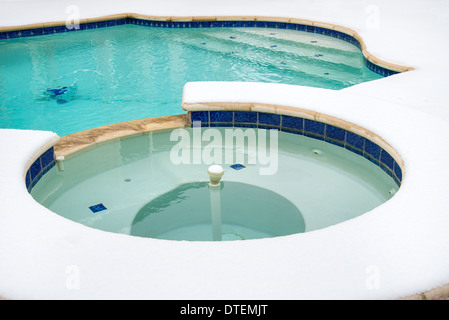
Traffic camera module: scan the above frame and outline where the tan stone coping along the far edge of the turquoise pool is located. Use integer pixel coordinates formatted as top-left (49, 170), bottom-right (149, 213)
top-left (0, 13), bottom-right (414, 72)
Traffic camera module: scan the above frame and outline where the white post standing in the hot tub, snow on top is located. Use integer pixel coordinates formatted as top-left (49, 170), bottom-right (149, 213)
top-left (207, 165), bottom-right (224, 241)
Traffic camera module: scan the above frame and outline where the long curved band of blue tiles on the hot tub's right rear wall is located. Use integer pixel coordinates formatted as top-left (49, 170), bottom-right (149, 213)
top-left (189, 110), bottom-right (403, 187)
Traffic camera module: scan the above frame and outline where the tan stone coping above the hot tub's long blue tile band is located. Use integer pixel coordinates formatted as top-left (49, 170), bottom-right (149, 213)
top-left (182, 102), bottom-right (405, 177)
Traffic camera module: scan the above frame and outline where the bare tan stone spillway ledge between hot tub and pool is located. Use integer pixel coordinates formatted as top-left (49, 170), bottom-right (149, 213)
top-left (54, 114), bottom-right (188, 158)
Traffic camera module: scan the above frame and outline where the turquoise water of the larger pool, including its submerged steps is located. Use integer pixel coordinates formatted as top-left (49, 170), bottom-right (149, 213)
top-left (0, 25), bottom-right (381, 136)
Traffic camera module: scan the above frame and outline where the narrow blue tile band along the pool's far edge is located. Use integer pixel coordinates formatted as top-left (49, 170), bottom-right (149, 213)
top-left (0, 18), bottom-right (400, 77)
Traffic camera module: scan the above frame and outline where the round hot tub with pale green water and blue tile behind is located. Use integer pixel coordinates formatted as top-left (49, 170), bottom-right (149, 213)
top-left (31, 111), bottom-right (402, 241)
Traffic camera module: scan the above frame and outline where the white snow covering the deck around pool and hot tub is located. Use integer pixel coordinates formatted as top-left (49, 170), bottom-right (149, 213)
top-left (0, 0), bottom-right (449, 299)
